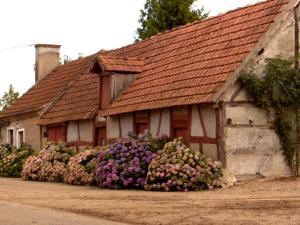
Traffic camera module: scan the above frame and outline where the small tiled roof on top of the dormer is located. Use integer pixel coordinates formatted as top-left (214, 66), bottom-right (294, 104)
top-left (99, 52), bottom-right (144, 73)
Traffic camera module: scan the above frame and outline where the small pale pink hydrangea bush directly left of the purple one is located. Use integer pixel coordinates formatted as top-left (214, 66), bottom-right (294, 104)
top-left (64, 147), bottom-right (108, 185)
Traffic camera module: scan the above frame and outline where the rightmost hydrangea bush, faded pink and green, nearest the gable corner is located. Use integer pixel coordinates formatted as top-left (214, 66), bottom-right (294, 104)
top-left (145, 139), bottom-right (222, 191)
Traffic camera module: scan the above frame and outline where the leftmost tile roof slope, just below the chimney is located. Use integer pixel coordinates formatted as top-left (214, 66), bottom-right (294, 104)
top-left (1, 55), bottom-right (96, 118)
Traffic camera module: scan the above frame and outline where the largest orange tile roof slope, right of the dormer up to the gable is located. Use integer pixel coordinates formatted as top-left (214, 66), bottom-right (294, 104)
top-left (102, 0), bottom-right (289, 115)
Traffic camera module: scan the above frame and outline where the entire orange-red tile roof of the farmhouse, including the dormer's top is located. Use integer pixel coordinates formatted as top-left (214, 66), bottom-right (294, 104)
top-left (1, 0), bottom-right (289, 124)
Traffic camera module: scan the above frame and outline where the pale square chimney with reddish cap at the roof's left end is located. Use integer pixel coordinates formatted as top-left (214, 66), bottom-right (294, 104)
top-left (35, 44), bottom-right (60, 82)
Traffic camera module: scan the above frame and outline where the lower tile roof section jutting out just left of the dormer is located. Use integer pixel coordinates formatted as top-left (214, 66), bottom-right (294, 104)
top-left (39, 74), bottom-right (99, 125)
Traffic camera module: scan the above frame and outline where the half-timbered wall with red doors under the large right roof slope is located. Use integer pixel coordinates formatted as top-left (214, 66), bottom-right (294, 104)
top-left (107, 105), bottom-right (222, 160)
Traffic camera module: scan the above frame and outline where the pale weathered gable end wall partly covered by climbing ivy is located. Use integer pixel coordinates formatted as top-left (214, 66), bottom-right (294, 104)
top-left (221, 7), bottom-right (294, 176)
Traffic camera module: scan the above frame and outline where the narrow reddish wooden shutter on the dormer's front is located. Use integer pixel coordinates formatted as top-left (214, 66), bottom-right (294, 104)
top-left (100, 76), bottom-right (111, 109)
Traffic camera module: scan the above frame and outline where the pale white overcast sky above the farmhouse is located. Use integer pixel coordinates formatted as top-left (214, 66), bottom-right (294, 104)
top-left (0, 0), bottom-right (258, 97)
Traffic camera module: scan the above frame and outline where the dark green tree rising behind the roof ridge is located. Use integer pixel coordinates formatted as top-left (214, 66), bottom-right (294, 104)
top-left (137, 0), bottom-right (208, 40)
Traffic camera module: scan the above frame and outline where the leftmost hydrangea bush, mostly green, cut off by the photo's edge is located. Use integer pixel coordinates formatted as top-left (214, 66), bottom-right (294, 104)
top-left (0, 144), bottom-right (33, 177)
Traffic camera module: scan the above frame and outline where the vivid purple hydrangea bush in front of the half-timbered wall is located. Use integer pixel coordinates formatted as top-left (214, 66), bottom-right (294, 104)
top-left (96, 131), bottom-right (167, 189)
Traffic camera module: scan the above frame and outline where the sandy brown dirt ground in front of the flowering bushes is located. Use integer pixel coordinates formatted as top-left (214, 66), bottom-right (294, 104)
top-left (0, 178), bottom-right (300, 225)
